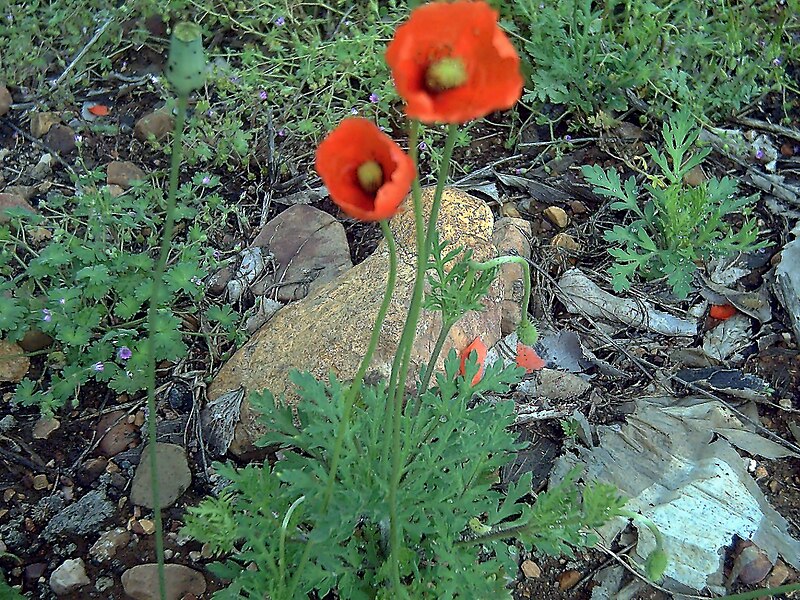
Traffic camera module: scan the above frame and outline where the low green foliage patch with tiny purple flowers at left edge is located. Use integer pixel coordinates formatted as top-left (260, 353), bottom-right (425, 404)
top-left (0, 173), bottom-right (234, 413)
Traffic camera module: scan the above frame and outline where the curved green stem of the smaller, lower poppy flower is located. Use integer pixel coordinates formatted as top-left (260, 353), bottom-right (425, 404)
top-left (286, 221), bottom-right (397, 598)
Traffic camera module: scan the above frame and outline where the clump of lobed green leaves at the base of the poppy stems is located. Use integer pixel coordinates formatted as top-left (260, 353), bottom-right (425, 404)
top-left (186, 351), bottom-right (622, 600)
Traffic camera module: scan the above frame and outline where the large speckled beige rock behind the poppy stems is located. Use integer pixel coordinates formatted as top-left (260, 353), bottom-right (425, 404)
top-left (208, 189), bottom-right (503, 454)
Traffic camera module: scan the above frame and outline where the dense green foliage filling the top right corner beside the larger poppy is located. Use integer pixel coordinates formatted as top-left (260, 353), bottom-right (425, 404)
top-left (507, 0), bottom-right (798, 119)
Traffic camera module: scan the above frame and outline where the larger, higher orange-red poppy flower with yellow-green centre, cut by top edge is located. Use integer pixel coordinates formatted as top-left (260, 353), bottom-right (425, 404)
top-left (386, 1), bottom-right (523, 123)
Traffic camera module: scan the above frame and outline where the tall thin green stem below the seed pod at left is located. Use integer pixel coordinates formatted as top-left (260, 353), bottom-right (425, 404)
top-left (147, 95), bottom-right (189, 600)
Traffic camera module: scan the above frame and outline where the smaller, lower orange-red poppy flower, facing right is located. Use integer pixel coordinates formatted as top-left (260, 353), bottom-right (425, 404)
top-left (316, 118), bottom-right (416, 221)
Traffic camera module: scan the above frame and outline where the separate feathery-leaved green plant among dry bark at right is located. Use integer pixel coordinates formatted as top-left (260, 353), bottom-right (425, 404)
top-left (582, 112), bottom-right (767, 298)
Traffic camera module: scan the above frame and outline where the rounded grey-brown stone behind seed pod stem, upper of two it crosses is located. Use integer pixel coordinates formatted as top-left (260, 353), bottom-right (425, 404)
top-left (131, 443), bottom-right (192, 508)
